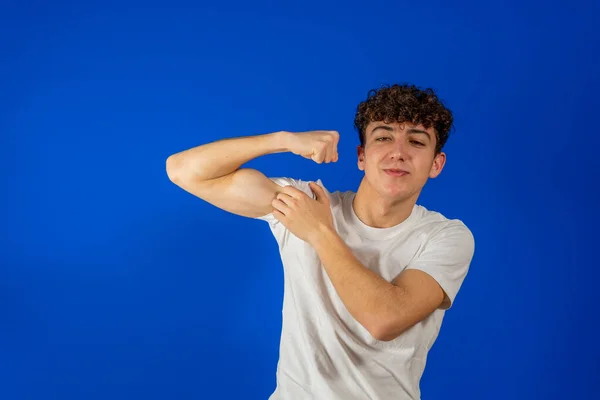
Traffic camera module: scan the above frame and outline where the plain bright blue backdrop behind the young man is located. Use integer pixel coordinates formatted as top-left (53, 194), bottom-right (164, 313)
top-left (0, 1), bottom-right (600, 400)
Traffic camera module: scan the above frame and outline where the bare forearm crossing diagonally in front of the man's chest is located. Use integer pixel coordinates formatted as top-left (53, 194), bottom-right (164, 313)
top-left (312, 230), bottom-right (402, 339)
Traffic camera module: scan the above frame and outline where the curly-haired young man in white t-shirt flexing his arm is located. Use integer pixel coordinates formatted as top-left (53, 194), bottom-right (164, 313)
top-left (167, 85), bottom-right (474, 400)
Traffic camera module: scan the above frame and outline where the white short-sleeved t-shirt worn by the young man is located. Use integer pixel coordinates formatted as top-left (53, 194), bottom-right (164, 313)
top-left (256, 178), bottom-right (474, 400)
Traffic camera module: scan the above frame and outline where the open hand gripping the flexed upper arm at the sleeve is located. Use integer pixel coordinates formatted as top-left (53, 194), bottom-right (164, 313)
top-left (272, 182), bottom-right (335, 244)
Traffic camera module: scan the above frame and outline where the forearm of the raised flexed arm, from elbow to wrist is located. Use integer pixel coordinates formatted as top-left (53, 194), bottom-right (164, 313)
top-left (167, 131), bottom-right (288, 180)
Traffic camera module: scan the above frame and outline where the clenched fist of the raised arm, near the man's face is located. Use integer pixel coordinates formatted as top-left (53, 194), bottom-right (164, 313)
top-left (286, 131), bottom-right (340, 164)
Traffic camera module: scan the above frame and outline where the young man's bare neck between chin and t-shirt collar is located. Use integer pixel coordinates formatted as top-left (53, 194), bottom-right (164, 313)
top-left (352, 177), bottom-right (419, 228)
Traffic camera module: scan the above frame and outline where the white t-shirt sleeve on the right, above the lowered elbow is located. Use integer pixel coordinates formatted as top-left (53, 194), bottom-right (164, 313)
top-left (406, 221), bottom-right (475, 310)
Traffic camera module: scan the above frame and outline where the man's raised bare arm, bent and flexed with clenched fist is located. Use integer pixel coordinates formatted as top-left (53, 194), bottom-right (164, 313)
top-left (166, 131), bottom-right (339, 218)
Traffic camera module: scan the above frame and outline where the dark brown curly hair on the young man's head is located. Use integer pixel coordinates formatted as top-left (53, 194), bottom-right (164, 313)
top-left (354, 84), bottom-right (454, 154)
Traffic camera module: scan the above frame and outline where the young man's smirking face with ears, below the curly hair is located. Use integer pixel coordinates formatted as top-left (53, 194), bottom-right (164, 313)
top-left (358, 122), bottom-right (446, 201)
